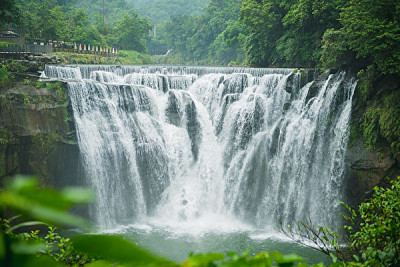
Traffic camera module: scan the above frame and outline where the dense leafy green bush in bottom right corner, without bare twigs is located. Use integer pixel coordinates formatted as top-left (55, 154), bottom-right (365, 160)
top-left (345, 177), bottom-right (400, 266)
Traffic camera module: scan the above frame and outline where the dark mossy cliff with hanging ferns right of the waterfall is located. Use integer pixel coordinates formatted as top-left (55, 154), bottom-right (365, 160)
top-left (347, 69), bottom-right (400, 204)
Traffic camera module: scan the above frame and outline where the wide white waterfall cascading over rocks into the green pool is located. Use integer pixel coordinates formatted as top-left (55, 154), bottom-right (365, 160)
top-left (43, 66), bottom-right (356, 229)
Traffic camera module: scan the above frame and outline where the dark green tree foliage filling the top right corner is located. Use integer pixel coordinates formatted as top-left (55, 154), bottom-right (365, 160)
top-left (340, 0), bottom-right (400, 74)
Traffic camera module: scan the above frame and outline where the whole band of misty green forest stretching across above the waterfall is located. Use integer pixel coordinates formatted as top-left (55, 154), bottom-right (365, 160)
top-left (0, 0), bottom-right (400, 74)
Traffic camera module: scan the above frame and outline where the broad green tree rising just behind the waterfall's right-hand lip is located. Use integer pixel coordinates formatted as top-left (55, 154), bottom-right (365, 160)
top-left (241, 0), bottom-right (346, 67)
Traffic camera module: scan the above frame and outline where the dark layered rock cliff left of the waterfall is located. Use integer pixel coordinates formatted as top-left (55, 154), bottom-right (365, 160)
top-left (0, 77), bottom-right (80, 186)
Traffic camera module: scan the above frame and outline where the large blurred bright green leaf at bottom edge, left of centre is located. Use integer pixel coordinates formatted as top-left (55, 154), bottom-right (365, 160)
top-left (72, 235), bottom-right (171, 264)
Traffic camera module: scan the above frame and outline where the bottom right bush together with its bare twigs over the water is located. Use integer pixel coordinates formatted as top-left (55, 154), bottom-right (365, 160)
top-left (282, 177), bottom-right (400, 266)
